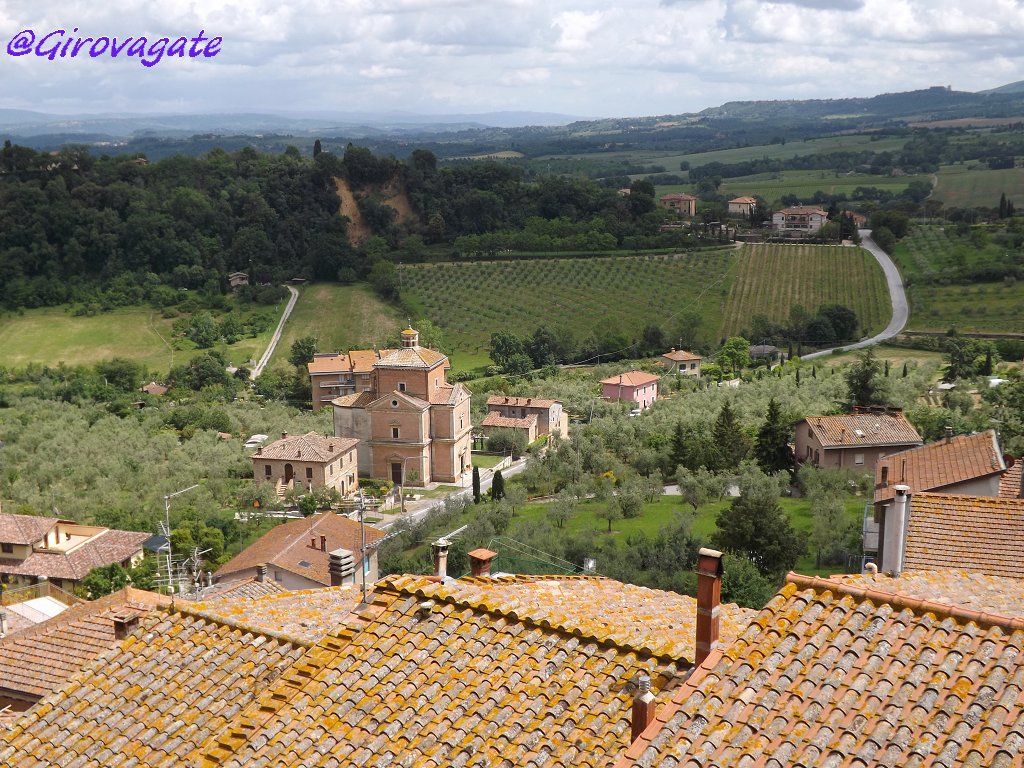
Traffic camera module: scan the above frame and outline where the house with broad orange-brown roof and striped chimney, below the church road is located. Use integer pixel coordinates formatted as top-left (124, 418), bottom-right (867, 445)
top-left (213, 512), bottom-right (384, 590)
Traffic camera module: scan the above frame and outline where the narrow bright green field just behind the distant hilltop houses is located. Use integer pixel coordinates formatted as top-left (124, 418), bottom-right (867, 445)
top-left (655, 171), bottom-right (933, 207)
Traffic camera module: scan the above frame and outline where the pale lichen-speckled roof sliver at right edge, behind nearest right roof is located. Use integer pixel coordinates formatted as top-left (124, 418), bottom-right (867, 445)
top-left (829, 568), bottom-right (1024, 618)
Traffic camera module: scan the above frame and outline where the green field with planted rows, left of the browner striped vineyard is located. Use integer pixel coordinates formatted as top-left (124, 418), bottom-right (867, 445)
top-left (401, 250), bottom-right (735, 364)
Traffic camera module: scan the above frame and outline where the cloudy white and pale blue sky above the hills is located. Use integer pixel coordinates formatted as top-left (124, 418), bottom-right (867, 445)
top-left (0, 0), bottom-right (1024, 117)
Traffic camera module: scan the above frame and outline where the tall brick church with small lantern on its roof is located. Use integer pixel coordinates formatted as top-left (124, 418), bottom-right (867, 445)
top-left (332, 328), bottom-right (471, 486)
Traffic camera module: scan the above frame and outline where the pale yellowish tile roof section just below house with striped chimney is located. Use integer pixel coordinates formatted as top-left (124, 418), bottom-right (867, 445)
top-left (191, 582), bottom-right (373, 643)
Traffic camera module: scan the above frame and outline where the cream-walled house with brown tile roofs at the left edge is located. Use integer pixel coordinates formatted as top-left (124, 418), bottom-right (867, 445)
top-left (0, 513), bottom-right (150, 592)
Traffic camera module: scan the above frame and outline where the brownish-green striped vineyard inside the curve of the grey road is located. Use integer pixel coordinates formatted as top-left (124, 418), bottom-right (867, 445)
top-left (721, 244), bottom-right (892, 336)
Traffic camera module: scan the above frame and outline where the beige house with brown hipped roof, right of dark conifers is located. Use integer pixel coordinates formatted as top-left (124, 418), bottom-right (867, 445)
top-left (796, 409), bottom-right (924, 474)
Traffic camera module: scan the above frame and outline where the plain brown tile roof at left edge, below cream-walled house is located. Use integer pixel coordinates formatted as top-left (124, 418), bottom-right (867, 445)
top-left (0, 587), bottom-right (170, 697)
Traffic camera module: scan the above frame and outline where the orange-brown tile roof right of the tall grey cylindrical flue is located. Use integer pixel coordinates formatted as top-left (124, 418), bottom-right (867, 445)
top-left (903, 494), bottom-right (1024, 579)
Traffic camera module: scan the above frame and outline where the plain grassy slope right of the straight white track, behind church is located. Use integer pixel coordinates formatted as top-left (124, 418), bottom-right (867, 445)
top-left (271, 283), bottom-right (406, 362)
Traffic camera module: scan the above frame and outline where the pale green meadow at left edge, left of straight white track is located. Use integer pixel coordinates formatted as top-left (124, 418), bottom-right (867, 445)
top-left (0, 304), bottom-right (284, 374)
